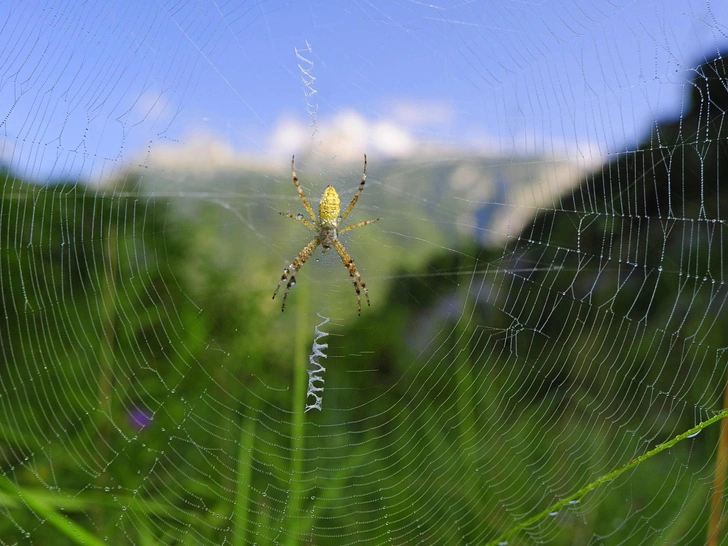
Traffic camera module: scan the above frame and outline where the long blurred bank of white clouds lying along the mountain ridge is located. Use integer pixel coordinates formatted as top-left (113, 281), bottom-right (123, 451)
top-left (131, 104), bottom-right (603, 179)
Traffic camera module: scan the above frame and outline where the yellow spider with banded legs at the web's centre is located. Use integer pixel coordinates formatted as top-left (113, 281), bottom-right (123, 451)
top-left (273, 154), bottom-right (379, 316)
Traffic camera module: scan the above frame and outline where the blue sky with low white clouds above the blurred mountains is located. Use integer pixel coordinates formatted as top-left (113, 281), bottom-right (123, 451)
top-left (0, 0), bottom-right (728, 178)
